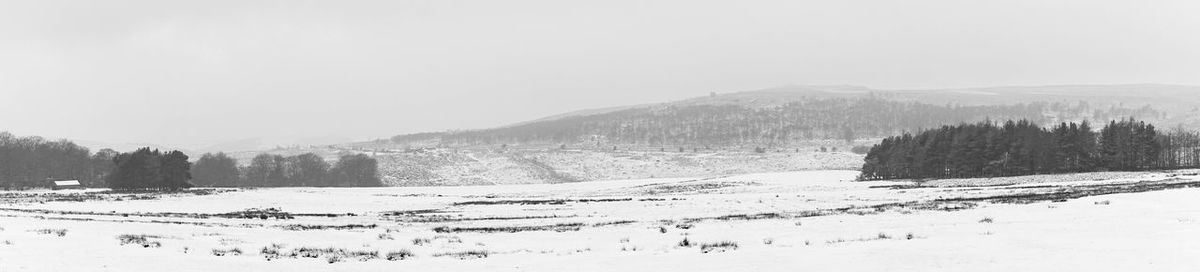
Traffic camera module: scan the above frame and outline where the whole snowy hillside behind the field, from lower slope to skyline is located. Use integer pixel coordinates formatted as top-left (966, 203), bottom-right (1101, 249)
top-left (343, 85), bottom-right (1200, 186)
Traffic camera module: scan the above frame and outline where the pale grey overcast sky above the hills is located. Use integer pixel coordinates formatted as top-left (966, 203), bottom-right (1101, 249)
top-left (0, 0), bottom-right (1200, 147)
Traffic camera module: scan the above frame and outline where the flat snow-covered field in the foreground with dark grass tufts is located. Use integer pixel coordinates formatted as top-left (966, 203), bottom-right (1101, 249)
top-left (0, 171), bottom-right (1200, 272)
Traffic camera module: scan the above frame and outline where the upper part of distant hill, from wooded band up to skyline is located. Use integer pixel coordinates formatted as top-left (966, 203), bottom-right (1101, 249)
top-left (391, 85), bottom-right (1200, 146)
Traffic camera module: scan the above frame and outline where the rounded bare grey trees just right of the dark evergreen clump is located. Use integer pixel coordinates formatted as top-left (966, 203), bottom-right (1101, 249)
top-left (192, 153), bottom-right (383, 187)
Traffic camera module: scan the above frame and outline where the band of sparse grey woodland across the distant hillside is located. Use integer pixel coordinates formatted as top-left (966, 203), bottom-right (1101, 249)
top-left (391, 97), bottom-right (1160, 146)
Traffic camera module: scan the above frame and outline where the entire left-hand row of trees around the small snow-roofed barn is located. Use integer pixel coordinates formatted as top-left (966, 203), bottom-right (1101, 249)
top-left (0, 132), bottom-right (383, 189)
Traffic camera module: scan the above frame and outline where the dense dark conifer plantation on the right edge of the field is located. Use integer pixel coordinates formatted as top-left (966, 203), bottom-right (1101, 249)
top-left (859, 119), bottom-right (1200, 180)
